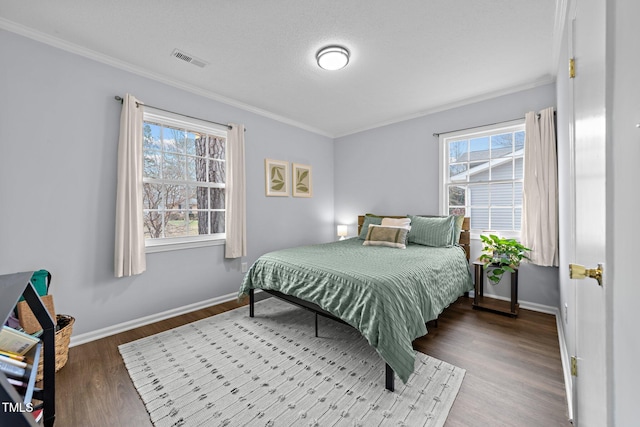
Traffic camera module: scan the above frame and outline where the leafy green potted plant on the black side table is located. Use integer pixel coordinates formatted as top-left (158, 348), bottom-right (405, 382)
top-left (478, 234), bottom-right (531, 285)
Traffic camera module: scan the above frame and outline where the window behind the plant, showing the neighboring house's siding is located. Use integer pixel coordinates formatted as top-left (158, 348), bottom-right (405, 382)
top-left (440, 121), bottom-right (525, 237)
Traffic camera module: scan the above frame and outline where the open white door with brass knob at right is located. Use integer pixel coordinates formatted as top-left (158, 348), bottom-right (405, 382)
top-left (569, 0), bottom-right (609, 427)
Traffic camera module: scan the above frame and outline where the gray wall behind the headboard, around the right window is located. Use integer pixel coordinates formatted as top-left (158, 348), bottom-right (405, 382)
top-left (334, 84), bottom-right (558, 308)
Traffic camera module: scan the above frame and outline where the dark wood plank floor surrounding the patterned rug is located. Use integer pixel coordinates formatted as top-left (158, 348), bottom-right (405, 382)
top-left (55, 298), bottom-right (571, 427)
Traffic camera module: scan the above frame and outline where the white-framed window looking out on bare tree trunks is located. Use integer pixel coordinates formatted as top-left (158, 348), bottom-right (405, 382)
top-left (143, 107), bottom-right (227, 251)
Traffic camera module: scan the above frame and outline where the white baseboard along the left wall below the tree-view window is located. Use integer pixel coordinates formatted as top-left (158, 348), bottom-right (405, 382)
top-left (69, 292), bottom-right (238, 347)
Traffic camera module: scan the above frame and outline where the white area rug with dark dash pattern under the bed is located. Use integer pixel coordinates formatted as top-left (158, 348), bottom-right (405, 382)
top-left (118, 298), bottom-right (465, 427)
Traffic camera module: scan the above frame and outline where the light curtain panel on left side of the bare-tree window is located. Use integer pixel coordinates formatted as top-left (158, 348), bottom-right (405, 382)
top-left (114, 94), bottom-right (147, 277)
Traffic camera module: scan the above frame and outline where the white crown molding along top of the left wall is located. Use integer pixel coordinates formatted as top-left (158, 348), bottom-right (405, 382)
top-left (0, 17), bottom-right (335, 138)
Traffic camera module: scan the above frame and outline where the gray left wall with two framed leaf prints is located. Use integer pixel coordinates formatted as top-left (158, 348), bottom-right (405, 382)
top-left (0, 30), bottom-right (335, 335)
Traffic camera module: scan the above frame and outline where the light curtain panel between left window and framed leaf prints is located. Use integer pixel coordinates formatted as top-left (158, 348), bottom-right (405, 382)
top-left (224, 124), bottom-right (247, 258)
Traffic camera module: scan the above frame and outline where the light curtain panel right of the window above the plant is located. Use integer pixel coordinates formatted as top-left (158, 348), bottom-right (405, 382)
top-left (520, 107), bottom-right (558, 266)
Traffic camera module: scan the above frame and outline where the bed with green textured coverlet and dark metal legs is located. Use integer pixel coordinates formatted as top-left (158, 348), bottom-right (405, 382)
top-left (239, 215), bottom-right (473, 391)
